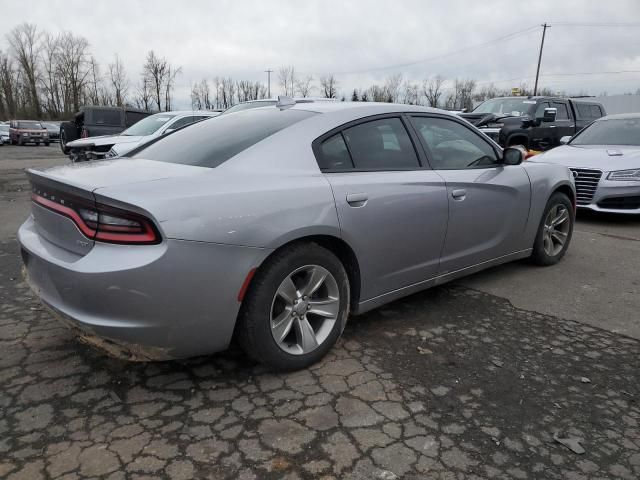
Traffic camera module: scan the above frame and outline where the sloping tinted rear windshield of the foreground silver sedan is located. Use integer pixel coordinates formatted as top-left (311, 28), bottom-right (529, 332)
top-left (133, 108), bottom-right (316, 168)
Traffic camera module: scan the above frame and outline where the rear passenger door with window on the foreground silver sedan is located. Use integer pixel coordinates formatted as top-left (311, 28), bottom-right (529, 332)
top-left (314, 116), bottom-right (448, 301)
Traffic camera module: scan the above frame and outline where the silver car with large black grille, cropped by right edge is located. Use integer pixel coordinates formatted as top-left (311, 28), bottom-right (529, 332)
top-left (532, 113), bottom-right (640, 215)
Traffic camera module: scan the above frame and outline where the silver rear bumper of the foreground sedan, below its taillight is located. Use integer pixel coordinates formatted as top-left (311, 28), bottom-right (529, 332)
top-left (18, 218), bottom-right (269, 360)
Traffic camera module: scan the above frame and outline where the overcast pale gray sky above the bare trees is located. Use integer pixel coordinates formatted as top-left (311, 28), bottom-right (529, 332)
top-left (0, 0), bottom-right (640, 107)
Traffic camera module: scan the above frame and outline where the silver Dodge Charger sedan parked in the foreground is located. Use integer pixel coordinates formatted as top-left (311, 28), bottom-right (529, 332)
top-left (18, 99), bottom-right (575, 369)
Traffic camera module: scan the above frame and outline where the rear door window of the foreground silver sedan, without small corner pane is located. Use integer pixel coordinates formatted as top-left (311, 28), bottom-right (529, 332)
top-left (343, 118), bottom-right (420, 170)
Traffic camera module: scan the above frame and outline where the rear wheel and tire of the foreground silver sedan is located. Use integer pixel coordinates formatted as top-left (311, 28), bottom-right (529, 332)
top-left (236, 243), bottom-right (349, 370)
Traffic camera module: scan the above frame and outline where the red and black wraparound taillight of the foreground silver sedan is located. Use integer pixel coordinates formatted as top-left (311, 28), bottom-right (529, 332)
top-left (31, 193), bottom-right (160, 245)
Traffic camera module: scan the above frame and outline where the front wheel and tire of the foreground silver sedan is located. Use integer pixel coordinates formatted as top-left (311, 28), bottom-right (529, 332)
top-left (531, 192), bottom-right (575, 266)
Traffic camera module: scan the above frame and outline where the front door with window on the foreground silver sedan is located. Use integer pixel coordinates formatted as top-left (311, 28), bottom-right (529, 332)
top-left (411, 116), bottom-right (531, 275)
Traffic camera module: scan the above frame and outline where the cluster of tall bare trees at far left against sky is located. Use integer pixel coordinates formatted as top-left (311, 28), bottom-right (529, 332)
top-left (0, 23), bottom-right (182, 120)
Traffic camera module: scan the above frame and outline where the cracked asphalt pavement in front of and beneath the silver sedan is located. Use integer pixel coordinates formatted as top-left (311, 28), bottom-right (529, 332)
top-left (0, 147), bottom-right (640, 480)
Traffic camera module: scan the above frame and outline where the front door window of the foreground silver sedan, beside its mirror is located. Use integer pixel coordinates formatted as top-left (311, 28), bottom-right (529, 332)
top-left (411, 117), bottom-right (498, 170)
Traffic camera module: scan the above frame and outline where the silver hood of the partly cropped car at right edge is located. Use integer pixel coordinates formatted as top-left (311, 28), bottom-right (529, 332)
top-left (528, 145), bottom-right (640, 171)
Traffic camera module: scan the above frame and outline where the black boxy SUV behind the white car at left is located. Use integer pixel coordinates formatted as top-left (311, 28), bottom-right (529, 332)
top-left (60, 106), bottom-right (151, 154)
